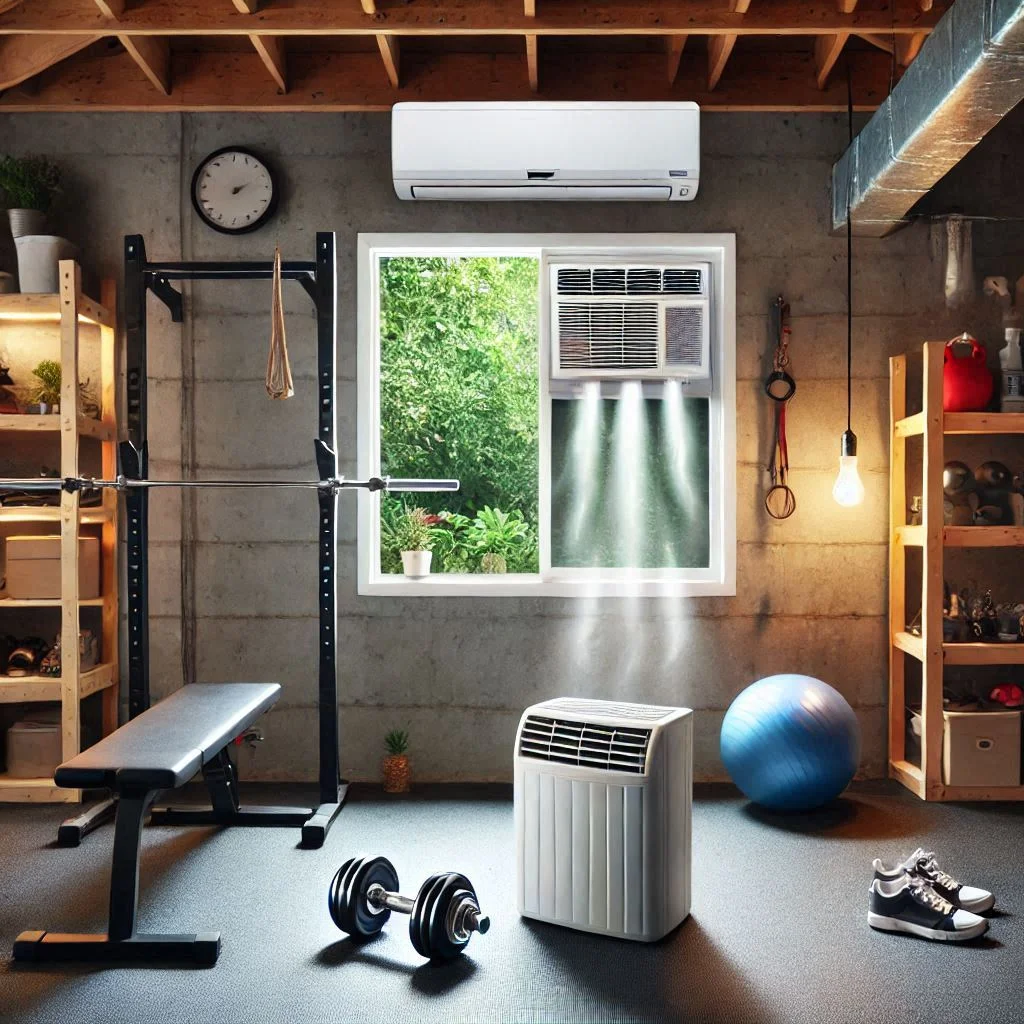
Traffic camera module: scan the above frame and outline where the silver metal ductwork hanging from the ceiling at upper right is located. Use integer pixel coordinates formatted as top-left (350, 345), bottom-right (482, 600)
top-left (831, 0), bottom-right (1024, 237)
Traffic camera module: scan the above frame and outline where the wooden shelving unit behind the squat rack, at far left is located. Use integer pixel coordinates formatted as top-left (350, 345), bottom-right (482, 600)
top-left (0, 260), bottom-right (120, 803)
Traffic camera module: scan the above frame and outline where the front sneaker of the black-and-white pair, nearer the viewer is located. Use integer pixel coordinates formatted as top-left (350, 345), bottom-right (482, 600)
top-left (867, 874), bottom-right (988, 942)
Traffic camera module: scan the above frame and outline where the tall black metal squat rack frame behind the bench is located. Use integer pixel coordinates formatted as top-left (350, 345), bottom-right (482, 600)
top-left (57, 231), bottom-right (347, 849)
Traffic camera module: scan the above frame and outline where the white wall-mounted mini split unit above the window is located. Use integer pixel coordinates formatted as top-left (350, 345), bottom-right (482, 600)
top-left (391, 102), bottom-right (700, 202)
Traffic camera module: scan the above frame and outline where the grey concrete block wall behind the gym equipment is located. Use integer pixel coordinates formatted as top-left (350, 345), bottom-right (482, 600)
top-left (0, 114), bottom-right (974, 779)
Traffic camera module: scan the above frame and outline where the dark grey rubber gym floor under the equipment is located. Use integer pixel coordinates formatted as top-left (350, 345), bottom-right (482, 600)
top-left (0, 784), bottom-right (1024, 1024)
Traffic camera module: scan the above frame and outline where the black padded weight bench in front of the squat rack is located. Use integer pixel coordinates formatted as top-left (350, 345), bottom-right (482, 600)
top-left (14, 683), bottom-right (281, 964)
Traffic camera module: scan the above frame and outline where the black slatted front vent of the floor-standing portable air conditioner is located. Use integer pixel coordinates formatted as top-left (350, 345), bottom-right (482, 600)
top-left (519, 715), bottom-right (650, 775)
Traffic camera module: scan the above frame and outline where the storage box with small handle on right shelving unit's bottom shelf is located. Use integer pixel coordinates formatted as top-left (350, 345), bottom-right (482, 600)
top-left (942, 711), bottom-right (1021, 786)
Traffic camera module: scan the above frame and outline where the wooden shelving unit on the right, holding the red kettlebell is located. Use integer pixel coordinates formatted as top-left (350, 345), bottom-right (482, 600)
top-left (889, 341), bottom-right (1024, 800)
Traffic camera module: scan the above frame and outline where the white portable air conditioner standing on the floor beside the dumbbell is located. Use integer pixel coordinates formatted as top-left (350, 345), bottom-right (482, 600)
top-left (515, 697), bottom-right (693, 942)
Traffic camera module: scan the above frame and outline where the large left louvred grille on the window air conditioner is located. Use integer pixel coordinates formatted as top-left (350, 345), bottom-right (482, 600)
top-left (558, 302), bottom-right (658, 370)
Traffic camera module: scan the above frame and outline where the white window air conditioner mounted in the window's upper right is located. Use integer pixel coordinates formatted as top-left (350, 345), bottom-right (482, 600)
top-left (551, 263), bottom-right (711, 380)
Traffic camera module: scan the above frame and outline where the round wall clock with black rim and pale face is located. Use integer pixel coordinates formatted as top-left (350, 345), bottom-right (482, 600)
top-left (191, 146), bottom-right (278, 234)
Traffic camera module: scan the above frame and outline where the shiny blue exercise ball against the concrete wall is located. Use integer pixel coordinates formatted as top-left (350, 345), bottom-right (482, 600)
top-left (721, 675), bottom-right (860, 811)
